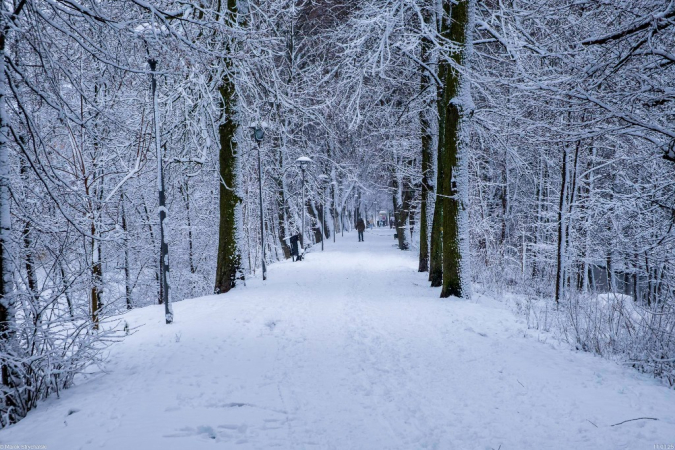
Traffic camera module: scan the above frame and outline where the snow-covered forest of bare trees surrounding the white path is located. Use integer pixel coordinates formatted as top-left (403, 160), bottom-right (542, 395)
top-left (0, 0), bottom-right (675, 426)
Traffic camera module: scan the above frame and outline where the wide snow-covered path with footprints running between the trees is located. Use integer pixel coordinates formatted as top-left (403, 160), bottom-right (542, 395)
top-left (0, 229), bottom-right (675, 450)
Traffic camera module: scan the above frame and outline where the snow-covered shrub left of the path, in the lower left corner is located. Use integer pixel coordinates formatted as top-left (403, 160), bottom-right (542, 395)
top-left (0, 286), bottom-right (124, 428)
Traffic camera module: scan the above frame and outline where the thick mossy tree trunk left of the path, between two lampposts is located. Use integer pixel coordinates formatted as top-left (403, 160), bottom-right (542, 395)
top-left (215, 0), bottom-right (243, 293)
